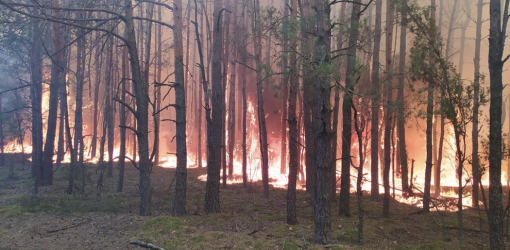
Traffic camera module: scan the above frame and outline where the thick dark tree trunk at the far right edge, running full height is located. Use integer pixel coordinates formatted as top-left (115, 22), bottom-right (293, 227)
top-left (489, 0), bottom-right (508, 249)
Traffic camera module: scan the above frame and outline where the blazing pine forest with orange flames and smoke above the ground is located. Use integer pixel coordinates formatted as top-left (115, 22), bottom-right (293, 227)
top-left (0, 0), bottom-right (510, 249)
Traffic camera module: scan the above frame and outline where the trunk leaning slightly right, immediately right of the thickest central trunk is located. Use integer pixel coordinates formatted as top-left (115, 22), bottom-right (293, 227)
top-left (339, 0), bottom-right (361, 216)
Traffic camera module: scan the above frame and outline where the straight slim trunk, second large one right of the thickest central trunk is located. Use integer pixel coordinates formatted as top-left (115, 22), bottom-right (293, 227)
top-left (370, 0), bottom-right (382, 201)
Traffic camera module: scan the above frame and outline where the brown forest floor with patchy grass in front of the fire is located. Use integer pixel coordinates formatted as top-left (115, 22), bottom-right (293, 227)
top-left (0, 155), bottom-right (509, 250)
